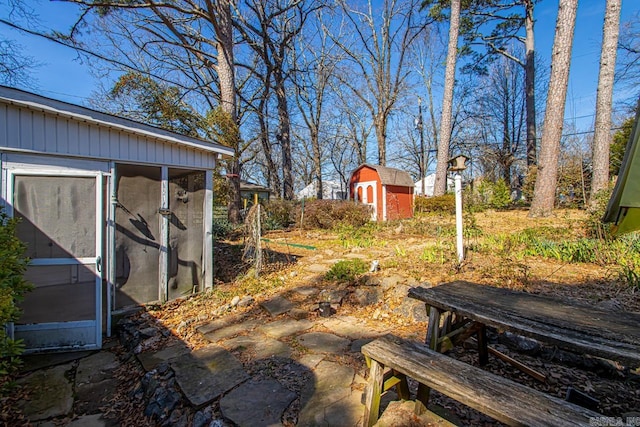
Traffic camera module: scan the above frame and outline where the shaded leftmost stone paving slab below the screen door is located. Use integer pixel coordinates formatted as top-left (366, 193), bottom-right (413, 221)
top-left (17, 364), bottom-right (73, 422)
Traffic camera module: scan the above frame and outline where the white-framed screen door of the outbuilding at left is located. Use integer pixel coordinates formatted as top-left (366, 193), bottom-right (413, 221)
top-left (3, 155), bottom-right (106, 352)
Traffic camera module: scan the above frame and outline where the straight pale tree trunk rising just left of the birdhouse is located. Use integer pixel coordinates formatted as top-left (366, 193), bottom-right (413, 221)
top-left (433, 0), bottom-right (460, 196)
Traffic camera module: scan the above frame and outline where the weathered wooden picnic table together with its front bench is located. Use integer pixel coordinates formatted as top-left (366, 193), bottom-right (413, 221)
top-left (362, 281), bottom-right (640, 426)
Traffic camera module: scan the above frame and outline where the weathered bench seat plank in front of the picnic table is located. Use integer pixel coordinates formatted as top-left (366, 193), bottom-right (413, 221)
top-left (362, 336), bottom-right (600, 427)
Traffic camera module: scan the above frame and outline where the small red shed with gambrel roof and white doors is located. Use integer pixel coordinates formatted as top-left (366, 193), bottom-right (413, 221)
top-left (349, 163), bottom-right (414, 221)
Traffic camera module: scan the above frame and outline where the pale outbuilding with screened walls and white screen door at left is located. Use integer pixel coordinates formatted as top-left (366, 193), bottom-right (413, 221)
top-left (0, 86), bottom-right (233, 352)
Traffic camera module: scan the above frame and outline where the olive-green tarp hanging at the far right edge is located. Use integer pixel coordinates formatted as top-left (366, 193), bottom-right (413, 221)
top-left (602, 104), bottom-right (640, 234)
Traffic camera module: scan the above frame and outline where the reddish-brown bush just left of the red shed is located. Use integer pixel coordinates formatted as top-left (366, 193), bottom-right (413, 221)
top-left (296, 200), bottom-right (371, 230)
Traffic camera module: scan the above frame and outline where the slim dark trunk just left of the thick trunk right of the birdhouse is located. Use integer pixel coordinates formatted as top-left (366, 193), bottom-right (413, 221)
top-left (524, 0), bottom-right (537, 168)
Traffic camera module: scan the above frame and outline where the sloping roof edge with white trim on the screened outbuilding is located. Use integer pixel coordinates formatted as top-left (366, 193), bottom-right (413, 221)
top-left (0, 85), bottom-right (233, 157)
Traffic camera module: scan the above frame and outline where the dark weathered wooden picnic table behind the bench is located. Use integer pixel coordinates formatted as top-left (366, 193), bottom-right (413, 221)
top-left (409, 281), bottom-right (640, 368)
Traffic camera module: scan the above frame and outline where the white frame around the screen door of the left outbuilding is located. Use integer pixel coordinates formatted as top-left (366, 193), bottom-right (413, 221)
top-left (2, 153), bottom-right (112, 353)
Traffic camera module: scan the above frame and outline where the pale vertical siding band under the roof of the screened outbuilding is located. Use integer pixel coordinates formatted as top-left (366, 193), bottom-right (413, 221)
top-left (0, 104), bottom-right (216, 169)
